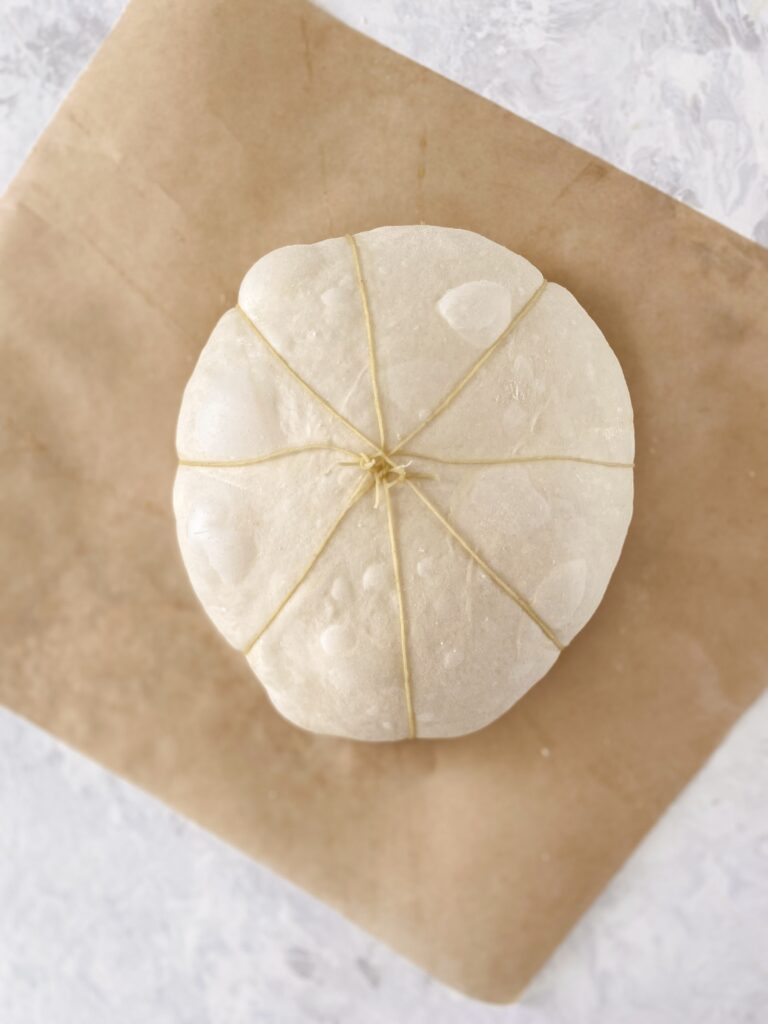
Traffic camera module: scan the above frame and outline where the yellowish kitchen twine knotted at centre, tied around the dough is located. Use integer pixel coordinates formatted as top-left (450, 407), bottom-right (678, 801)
top-left (179, 234), bottom-right (634, 739)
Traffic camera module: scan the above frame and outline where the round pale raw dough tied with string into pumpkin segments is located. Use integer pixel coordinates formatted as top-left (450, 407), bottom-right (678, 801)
top-left (174, 225), bottom-right (634, 739)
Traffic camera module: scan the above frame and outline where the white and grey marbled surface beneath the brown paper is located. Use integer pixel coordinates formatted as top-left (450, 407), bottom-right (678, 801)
top-left (0, 0), bottom-right (768, 1024)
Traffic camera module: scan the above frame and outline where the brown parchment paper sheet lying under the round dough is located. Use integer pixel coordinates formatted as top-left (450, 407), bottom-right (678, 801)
top-left (0, 0), bottom-right (768, 1000)
